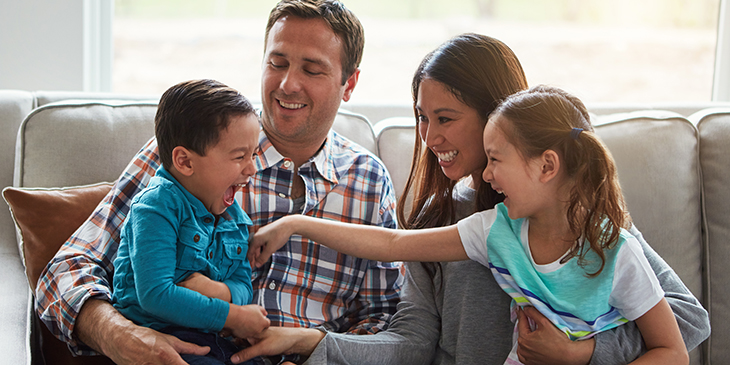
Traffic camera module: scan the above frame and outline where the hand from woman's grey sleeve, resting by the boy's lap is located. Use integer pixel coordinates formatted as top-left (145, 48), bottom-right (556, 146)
top-left (231, 327), bottom-right (324, 364)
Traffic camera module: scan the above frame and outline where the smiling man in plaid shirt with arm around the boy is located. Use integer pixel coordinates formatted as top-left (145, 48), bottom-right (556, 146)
top-left (36, 0), bottom-right (403, 364)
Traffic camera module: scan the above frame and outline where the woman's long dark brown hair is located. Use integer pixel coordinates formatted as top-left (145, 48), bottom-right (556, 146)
top-left (397, 33), bottom-right (527, 229)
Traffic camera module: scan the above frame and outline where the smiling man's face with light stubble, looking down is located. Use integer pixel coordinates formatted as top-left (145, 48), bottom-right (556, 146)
top-left (261, 16), bottom-right (359, 145)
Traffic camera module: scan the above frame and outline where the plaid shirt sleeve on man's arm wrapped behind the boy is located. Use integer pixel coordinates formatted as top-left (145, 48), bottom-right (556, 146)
top-left (35, 138), bottom-right (159, 355)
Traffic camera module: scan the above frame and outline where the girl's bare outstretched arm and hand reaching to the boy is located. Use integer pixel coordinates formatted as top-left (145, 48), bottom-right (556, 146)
top-left (248, 214), bottom-right (468, 267)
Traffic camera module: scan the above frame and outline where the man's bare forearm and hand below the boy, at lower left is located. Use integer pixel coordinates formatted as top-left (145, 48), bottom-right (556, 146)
top-left (74, 299), bottom-right (210, 365)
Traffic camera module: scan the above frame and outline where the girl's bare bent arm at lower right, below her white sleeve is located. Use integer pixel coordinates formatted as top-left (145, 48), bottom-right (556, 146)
top-left (631, 298), bottom-right (689, 365)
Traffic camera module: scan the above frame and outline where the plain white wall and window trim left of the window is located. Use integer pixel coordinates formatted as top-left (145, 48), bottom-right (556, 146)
top-left (0, 0), bottom-right (113, 91)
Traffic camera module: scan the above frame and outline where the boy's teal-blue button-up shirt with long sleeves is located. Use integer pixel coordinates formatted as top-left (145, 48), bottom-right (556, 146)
top-left (113, 167), bottom-right (252, 331)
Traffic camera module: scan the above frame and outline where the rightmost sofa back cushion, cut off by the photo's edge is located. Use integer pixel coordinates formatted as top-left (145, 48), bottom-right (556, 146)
top-left (691, 108), bottom-right (730, 364)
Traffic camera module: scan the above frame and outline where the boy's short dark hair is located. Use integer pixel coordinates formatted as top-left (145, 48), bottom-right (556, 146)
top-left (155, 80), bottom-right (255, 170)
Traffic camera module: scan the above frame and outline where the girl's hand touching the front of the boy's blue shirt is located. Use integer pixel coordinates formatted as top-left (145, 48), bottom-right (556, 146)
top-left (248, 216), bottom-right (295, 267)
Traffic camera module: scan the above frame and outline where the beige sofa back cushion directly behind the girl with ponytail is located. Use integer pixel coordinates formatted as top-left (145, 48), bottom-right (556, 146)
top-left (596, 111), bottom-right (704, 299)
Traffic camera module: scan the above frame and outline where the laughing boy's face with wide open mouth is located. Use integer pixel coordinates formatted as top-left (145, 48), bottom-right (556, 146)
top-left (186, 113), bottom-right (259, 215)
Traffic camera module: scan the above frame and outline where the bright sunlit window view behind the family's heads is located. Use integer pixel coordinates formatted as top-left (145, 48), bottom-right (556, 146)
top-left (112, 0), bottom-right (719, 103)
